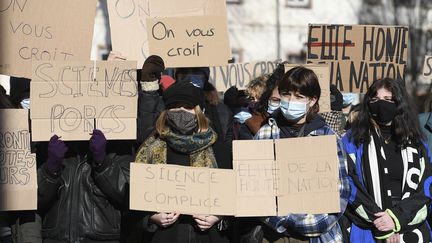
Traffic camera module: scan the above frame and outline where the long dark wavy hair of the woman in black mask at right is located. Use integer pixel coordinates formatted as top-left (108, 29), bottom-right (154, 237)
top-left (351, 78), bottom-right (423, 146)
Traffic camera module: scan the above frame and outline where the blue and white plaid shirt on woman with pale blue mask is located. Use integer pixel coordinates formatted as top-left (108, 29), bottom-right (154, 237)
top-left (254, 119), bottom-right (351, 243)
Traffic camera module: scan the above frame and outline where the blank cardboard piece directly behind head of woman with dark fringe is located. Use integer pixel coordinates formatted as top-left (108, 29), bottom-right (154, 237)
top-left (285, 64), bottom-right (331, 112)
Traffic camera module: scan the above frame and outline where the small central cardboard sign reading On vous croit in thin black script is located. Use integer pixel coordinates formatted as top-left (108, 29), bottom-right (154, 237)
top-left (147, 16), bottom-right (230, 67)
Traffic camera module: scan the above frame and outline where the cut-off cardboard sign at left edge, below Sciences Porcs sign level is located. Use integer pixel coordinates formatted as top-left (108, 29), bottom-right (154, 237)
top-left (0, 109), bottom-right (37, 211)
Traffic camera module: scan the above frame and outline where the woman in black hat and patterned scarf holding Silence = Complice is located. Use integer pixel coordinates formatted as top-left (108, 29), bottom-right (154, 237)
top-left (135, 82), bottom-right (228, 243)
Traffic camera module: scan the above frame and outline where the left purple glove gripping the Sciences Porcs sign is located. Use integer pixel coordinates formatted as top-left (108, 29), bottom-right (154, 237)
top-left (47, 135), bottom-right (68, 174)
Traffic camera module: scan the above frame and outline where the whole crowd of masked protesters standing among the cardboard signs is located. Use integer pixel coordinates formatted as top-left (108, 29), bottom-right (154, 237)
top-left (0, 53), bottom-right (432, 243)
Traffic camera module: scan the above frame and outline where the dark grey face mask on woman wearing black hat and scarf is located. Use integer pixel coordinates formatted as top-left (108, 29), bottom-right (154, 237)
top-left (167, 110), bottom-right (198, 135)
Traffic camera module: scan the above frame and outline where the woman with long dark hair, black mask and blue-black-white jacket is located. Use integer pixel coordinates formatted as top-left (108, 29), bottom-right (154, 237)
top-left (343, 78), bottom-right (432, 242)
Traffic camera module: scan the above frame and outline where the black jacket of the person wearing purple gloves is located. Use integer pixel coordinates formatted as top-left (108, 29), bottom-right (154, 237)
top-left (38, 154), bottom-right (131, 243)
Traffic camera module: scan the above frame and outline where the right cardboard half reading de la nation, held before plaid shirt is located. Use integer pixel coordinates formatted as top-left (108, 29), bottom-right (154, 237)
top-left (276, 136), bottom-right (340, 215)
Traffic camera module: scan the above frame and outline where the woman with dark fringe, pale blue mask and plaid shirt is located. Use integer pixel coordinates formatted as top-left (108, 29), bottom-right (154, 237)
top-left (255, 67), bottom-right (350, 242)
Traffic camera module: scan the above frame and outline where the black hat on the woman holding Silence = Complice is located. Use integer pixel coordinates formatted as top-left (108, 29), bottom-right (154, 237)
top-left (163, 82), bottom-right (204, 108)
